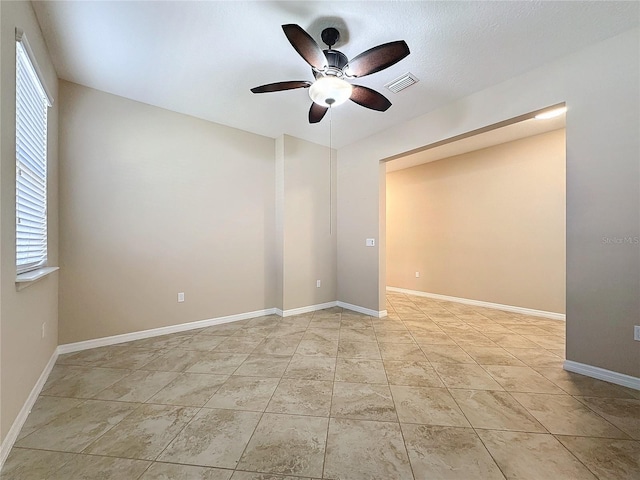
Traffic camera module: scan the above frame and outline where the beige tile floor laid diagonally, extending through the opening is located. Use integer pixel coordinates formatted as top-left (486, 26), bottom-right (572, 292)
top-left (0, 294), bottom-right (640, 480)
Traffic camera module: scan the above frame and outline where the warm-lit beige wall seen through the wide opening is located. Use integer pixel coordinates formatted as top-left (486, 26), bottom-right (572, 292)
top-left (386, 129), bottom-right (566, 313)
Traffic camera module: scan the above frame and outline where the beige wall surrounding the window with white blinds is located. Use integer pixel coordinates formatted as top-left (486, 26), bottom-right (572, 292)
top-left (0, 2), bottom-right (59, 440)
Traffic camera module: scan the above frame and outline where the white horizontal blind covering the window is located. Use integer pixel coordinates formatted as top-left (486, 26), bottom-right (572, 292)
top-left (16, 41), bottom-right (49, 273)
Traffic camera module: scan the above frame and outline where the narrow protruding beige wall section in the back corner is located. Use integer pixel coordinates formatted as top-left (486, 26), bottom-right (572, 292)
top-left (276, 135), bottom-right (337, 311)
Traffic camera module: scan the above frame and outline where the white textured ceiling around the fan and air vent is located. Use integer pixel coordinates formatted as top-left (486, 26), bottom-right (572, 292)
top-left (33, 1), bottom-right (640, 147)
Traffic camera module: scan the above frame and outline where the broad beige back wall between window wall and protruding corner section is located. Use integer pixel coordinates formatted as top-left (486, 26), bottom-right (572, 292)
top-left (60, 81), bottom-right (276, 344)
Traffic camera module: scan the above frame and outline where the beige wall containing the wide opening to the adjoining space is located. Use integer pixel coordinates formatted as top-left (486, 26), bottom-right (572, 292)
top-left (338, 29), bottom-right (640, 377)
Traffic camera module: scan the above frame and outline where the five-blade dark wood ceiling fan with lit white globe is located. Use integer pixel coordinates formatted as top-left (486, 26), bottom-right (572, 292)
top-left (251, 24), bottom-right (410, 123)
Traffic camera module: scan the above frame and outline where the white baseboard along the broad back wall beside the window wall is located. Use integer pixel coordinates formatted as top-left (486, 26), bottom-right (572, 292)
top-left (58, 308), bottom-right (276, 354)
